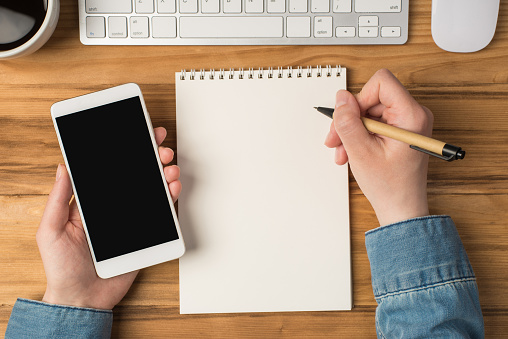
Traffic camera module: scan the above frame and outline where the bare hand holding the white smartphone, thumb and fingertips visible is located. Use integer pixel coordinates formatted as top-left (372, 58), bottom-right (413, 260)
top-left (37, 127), bottom-right (182, 309)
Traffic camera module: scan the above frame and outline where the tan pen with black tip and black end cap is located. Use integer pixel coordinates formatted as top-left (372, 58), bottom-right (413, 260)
top-left (314, 107), bottom-right (466, 161)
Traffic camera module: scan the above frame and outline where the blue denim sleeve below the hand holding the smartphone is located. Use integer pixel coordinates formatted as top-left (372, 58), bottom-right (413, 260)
top-left (5, 298), bottom-right (113, 339)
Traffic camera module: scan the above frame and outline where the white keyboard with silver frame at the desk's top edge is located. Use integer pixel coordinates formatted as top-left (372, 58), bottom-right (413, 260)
top-left (78, 0), bottom-right (409, 45)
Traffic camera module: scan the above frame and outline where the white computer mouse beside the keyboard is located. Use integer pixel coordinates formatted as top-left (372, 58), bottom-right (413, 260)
top-left (432, 0), bottom-right (500, 53)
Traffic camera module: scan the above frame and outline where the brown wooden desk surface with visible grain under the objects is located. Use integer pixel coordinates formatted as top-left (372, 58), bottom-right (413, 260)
top-left (0, 0), bottom-right (508, 338)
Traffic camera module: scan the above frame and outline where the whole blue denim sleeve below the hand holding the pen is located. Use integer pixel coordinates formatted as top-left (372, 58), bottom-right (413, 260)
top-left (365, 216), bottom-right (484, 338)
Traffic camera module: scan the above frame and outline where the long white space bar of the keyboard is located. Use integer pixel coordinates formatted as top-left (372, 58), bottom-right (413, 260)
top-left (180, 16), bottom-right (283, 38)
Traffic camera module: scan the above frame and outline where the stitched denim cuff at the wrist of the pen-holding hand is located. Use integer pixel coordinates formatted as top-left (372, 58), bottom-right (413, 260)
top-left (365, 216), bottom-right (475, 299)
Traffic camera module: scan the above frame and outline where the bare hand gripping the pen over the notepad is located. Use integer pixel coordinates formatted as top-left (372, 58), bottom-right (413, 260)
top-left (325, 70), bottom-right (433, 225)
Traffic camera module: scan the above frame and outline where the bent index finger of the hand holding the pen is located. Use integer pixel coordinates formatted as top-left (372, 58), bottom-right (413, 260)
top-left (356, 69), bottom-right (415, 112)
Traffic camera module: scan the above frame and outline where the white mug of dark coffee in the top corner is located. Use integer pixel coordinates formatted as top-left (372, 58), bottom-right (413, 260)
top-left (0, 0), bottom-right (60, 60)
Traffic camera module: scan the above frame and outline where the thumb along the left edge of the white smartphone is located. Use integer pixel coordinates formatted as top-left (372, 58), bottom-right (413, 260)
top-left (39, 164), bottom-right (72, 232)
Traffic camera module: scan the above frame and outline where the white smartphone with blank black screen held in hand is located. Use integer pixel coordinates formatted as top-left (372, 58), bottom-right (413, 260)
top-left (51, 84), bottom-right (185, 278)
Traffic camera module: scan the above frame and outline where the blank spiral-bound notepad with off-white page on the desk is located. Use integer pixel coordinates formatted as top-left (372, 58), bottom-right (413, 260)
top-left (176, 66), bottom-right (352, 314)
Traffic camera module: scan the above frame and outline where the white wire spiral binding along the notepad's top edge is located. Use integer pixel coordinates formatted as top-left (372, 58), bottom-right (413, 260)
top-left (180, 65), bottom-right (342, 80)
